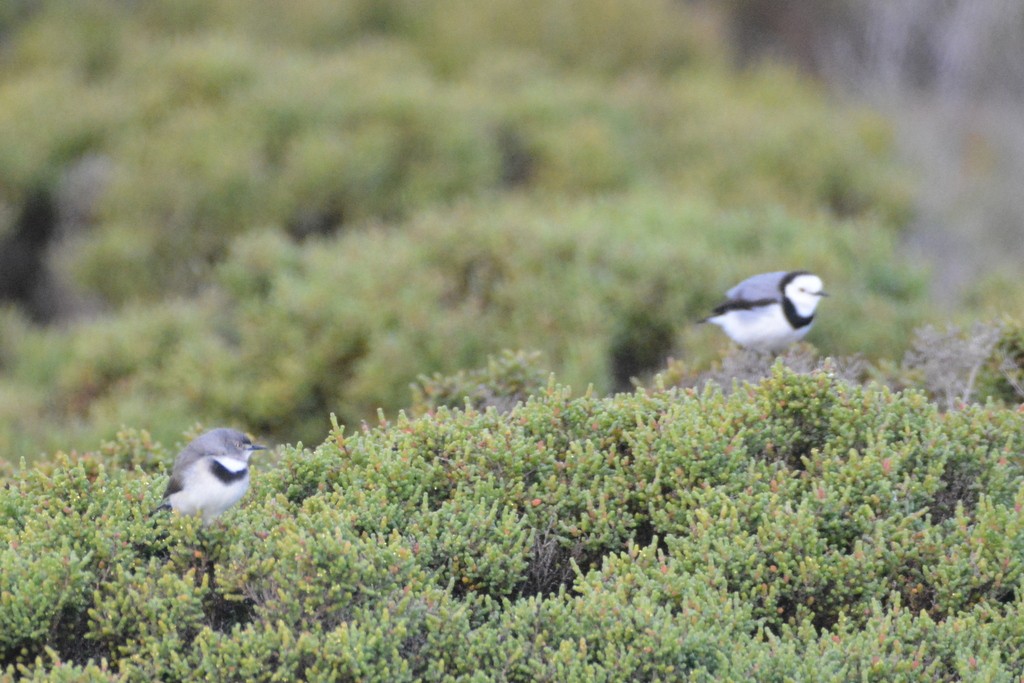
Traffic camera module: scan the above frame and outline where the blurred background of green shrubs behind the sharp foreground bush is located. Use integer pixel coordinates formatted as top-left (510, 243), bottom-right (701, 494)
top-left (0, 0), bottom-right (1024, 462)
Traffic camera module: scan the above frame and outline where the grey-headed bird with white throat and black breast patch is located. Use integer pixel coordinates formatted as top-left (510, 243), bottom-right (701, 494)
top-left (151, 428), bottom-right (266, 524)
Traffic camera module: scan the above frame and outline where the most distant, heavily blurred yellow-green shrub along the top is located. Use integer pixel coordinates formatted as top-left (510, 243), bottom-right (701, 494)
top-left (0, 0), bottom-right (908, 307)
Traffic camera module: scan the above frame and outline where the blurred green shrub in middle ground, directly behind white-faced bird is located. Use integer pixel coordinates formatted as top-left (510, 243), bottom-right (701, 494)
top-left (0, 191), bottom-right (925, 462)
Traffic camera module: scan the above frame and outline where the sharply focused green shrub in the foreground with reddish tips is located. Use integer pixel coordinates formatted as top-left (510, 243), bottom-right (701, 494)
top-left (0, 364), bottom-right (1024, 681)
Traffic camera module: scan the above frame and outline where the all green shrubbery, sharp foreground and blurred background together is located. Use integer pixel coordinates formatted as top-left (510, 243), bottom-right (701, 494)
top-left (0, 0), bottom-right (1024, 681)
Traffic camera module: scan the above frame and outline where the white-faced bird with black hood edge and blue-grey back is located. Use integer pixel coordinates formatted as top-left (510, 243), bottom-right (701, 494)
top-left (700, 270), bottom-right (828, 351)
